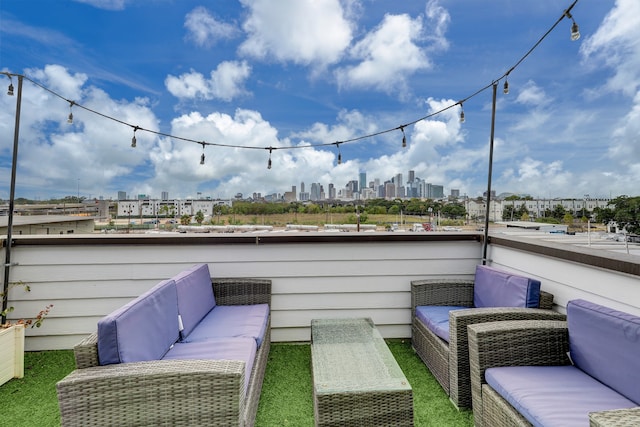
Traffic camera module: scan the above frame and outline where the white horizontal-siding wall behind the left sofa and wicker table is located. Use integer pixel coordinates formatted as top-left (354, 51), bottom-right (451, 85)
top-left (1, 233), bottom-right (481, 350)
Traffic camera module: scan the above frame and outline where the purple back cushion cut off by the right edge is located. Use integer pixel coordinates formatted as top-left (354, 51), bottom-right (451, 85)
top-left (567, 300), bottom-right (640, 405)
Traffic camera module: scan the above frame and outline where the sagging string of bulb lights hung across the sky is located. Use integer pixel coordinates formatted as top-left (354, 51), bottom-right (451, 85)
top-left (0, 0), bottom-right (580, 164)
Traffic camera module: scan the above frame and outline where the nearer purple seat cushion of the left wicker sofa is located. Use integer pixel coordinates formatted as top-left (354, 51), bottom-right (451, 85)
top-left (163, 337), bottom-right (257, 392)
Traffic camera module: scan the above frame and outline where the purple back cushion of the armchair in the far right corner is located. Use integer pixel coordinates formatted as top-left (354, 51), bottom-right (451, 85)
top-left (473, 265), bottom-right (540, 308)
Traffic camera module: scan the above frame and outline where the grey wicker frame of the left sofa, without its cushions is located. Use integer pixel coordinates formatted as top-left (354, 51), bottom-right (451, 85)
top-left (57, 279), bottom-right (271, 426)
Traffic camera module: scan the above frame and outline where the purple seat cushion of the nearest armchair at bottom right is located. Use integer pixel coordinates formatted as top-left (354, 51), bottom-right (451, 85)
top-left (485, 366), bottom-right (637, 427)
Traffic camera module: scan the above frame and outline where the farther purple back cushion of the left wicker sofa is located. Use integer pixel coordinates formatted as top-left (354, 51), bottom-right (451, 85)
top-left (173, 264), bottom-right (216, 338)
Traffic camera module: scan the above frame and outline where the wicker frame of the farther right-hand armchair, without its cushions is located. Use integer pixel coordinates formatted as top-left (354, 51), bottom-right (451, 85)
top-left (411, 279), bottom-right (565, 408)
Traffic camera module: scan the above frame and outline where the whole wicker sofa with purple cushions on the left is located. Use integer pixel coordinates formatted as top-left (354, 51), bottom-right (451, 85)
top-left (57, 264), bottom-right (271, 426)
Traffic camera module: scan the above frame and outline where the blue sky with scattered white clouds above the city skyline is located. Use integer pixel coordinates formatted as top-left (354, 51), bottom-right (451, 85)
top-left (0, 0), bottom-right (640, 199)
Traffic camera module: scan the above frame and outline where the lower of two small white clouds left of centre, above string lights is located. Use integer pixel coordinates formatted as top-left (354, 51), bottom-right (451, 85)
top-left (165, 61), bottom-right (251, 102)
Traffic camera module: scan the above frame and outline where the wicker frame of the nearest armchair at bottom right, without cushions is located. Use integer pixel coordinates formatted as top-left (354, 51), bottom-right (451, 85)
top-left (468, 320), bottom-right (640, 427)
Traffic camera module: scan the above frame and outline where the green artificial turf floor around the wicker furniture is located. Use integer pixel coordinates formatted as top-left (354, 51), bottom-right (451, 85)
top-left (0, 340), bottom-right (473, 427)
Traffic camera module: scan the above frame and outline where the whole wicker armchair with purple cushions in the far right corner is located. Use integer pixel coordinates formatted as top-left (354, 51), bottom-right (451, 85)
top-left (411, 265), bottom-right (565, 408)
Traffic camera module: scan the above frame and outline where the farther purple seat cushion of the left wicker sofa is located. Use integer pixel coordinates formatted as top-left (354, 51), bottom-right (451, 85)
top-left (182, 304), bottom-right (269, 347)
